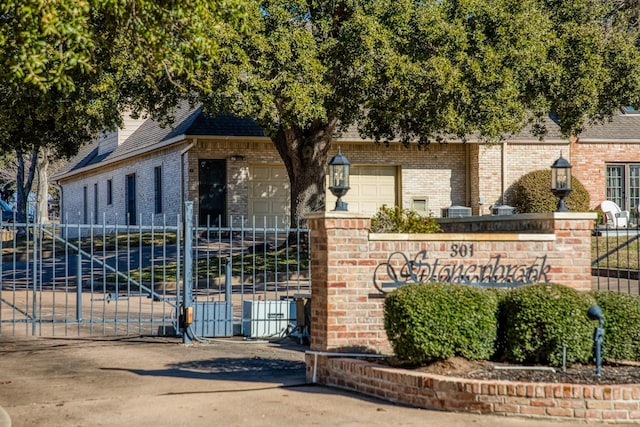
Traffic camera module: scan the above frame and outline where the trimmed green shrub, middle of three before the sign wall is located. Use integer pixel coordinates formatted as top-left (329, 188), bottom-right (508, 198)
top-left (498, 284), bottom-right (595, 366)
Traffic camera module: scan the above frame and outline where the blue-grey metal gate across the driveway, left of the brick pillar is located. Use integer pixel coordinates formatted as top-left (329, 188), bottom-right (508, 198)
top-left (0, 202), bottom-right (310, 340)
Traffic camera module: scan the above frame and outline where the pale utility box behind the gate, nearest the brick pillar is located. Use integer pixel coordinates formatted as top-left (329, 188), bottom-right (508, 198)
top-left (242, 299), bottom-right (296, 337)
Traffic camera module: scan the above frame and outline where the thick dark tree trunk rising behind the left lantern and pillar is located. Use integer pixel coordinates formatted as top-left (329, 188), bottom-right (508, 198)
top-left (272, 120), bottom-right (336, 227)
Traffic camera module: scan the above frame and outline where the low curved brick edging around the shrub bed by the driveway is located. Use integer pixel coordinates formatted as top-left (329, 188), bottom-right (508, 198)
top-left (306, 356), bottom-right (640, 424)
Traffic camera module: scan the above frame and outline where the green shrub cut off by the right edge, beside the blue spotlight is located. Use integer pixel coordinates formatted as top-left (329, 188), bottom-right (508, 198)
top-left (592, 291), bottom-right (640, 361)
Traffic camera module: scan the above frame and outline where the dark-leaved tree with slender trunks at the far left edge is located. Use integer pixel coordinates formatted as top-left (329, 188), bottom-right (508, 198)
top-left (0, 83), bottom-right (119, 221)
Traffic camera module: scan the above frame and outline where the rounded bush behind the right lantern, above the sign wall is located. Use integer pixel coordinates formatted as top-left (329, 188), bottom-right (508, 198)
top-left (509, 169), bottom-right (591, 213)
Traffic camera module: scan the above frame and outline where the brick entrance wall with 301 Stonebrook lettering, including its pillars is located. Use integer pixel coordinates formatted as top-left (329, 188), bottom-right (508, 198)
top-left (307, 212), bottom-right (595, 353)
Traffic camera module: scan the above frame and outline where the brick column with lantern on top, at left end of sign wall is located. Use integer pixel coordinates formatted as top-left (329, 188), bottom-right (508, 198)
top-left (307, 212), bottom-right (389, 352)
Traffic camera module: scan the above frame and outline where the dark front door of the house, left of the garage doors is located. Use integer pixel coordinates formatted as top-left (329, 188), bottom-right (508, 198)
top-left (198, 159), bottom-right (227, 226)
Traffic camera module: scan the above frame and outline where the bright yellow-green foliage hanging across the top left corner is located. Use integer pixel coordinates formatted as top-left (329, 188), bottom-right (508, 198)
top-left (0, 0), bottom-right (248, 93)
